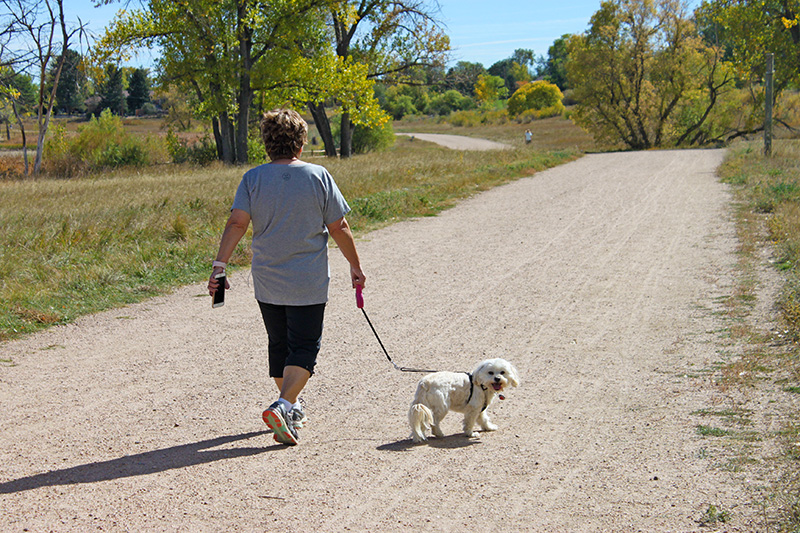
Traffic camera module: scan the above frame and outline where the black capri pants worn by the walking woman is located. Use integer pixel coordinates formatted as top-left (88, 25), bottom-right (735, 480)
top-left (258, 302), bottom-right (325, 378)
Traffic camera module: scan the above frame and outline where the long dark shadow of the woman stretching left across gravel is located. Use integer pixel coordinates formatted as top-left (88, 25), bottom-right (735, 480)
top-left (0, 431), bottom-right (274, 494)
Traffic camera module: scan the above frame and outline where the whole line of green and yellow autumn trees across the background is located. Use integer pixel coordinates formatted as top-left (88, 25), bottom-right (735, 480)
top-left (0, 0), bottom-right (800, 175)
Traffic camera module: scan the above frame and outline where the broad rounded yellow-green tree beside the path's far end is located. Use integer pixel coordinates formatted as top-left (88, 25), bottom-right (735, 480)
top-left (567, 0), bottom-right (733, 149)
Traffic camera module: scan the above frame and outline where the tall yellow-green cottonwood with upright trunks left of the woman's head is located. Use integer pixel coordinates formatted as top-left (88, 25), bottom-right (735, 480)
top-left (96, 0), bottom-right (384, 163)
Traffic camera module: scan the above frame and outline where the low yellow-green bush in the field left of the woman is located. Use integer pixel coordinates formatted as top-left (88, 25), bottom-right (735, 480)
top-left (45, 109), bottom-right (165, 178)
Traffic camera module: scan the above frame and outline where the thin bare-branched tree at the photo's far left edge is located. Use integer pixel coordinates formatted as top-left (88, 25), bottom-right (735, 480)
top-left (0, 0), bottom-right (82, 175)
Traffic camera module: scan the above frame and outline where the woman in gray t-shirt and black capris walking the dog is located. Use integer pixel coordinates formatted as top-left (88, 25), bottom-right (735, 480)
top-left (208, 109), bottom-right (366, 446)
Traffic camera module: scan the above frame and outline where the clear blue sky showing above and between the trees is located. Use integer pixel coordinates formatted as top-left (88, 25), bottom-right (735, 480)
top-left (70, 0), bottom-right (699, 68)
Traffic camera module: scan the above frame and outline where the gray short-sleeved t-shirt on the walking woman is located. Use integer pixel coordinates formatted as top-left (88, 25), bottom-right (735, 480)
top-left (232, 162), bottom-right (350, 305)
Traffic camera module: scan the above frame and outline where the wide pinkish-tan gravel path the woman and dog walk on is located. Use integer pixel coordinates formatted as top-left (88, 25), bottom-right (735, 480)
top-left (0, 150), bottom-right (770, 533)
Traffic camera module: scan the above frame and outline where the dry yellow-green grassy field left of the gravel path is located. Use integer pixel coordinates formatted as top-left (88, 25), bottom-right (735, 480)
top-left (0, 119), bottom-right (590, 340)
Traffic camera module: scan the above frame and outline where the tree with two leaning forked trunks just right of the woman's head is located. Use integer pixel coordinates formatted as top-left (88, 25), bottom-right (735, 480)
top-left (309, 0), bottom-right (450, 157)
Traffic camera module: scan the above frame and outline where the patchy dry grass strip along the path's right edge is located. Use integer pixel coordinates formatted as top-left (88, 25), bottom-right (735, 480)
top-left (717, 140), bottom-right (800, 532)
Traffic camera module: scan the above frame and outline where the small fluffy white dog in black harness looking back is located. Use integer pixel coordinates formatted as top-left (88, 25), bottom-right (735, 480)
top-left (408, 359), bottom-right (519, 442)
